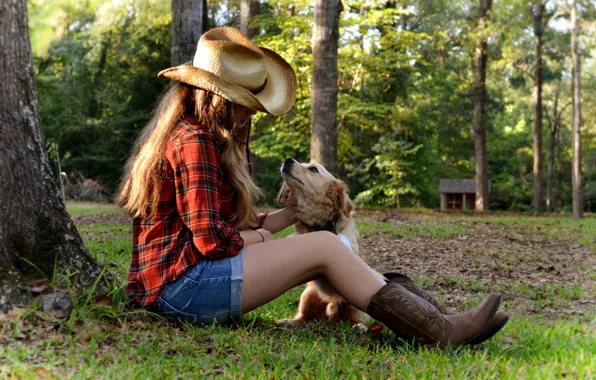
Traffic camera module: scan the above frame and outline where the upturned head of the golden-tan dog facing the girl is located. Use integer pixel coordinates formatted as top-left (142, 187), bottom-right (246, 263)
top-left (278, 158), bottom-right (354, 224)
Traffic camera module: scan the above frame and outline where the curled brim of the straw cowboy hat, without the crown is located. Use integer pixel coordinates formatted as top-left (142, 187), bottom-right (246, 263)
top-left (158, 47), bottom-right (296, 116)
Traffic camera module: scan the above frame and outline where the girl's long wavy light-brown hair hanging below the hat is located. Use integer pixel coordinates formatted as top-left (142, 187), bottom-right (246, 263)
top-left (117, 82), bottom-right (261, 229)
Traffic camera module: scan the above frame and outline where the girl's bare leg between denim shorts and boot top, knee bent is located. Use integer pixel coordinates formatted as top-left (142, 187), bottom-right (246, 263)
top-left (242, 231), bottom-right (385, 313)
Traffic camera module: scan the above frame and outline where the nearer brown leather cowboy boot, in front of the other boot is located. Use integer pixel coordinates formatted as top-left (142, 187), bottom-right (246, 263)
top-left (367, 282), bottom-right (501, 347)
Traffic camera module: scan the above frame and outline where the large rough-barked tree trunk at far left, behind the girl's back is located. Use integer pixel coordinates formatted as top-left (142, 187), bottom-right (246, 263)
top-left (0, 0), bottom-right (104, 311)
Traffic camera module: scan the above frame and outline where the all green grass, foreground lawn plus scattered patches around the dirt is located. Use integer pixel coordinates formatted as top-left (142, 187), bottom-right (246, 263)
top-left (0, 207), bottom-right (596, 379)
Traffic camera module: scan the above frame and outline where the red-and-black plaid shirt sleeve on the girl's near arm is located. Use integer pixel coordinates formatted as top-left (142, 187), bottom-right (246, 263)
top-left (166, 131), bottom-right (244, 259)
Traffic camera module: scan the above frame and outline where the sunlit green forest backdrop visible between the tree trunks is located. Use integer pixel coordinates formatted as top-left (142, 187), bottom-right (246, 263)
top-left (28, 0), bottom-right (596, 212)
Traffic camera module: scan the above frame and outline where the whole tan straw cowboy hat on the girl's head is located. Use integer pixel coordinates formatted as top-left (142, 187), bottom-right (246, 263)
top-left (158, 27), bottom-right (296, 116)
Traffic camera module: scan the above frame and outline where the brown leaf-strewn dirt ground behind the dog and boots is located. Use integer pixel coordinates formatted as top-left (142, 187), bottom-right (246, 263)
top-left (73, 211), bottom-right (596, 318)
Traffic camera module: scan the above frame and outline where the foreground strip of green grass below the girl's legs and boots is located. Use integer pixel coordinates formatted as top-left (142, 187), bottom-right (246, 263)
top-left (0, 308), bottom-right (596, 379)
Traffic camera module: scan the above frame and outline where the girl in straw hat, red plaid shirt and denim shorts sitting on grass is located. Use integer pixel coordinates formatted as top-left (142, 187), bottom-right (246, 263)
top-left (119, 27), bottom-right (502, 346)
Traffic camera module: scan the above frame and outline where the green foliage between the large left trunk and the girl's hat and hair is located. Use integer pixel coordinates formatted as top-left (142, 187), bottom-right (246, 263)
top-left (32, 1), bottom-right (170, 190)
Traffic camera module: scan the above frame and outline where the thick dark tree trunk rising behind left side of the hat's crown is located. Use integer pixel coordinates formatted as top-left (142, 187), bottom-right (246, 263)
top-left (170, 0), bottom-right (208, 66)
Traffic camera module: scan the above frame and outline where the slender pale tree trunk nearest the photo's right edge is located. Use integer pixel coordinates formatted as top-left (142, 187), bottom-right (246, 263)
top-left (571, 0), bottom-right (584, 218)
